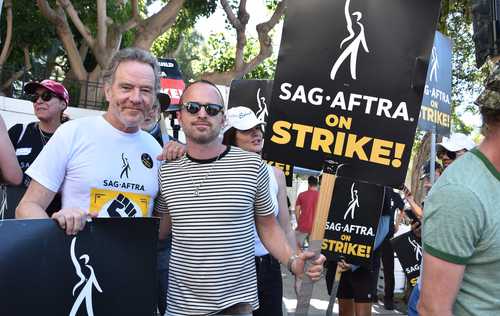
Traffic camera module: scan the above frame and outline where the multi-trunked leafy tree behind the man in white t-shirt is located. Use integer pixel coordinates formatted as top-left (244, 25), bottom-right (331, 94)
top-left (25, 0), bottom-right (216, 107)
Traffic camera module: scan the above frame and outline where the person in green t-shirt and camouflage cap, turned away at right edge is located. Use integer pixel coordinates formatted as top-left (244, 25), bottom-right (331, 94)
top-left (418, 67), bottom-right (500, 316)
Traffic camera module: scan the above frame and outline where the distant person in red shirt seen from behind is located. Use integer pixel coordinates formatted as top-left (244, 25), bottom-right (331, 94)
top-left (295, 176), bottom-right (319, 248)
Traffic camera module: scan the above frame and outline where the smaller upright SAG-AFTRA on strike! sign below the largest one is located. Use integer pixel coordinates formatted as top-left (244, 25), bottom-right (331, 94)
top-left (321, 177), bottom-right (384, 266)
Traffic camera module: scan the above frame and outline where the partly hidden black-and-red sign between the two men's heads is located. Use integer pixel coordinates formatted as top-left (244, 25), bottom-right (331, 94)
top-left (158, 58), bottom-right (186, 104)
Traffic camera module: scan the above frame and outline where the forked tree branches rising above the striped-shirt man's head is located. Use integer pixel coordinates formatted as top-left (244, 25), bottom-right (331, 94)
top-left (200, 0), bottom-right (287, 85)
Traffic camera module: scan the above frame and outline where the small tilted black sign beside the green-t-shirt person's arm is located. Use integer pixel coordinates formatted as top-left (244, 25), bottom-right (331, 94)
top-left (391, 231), bottom-right (422, 286)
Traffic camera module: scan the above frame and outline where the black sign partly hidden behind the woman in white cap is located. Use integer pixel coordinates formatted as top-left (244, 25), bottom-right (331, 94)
top-left (227, 80), bottom-right (293, 187)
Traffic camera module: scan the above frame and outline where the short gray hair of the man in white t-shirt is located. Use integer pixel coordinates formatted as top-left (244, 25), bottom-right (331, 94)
top-left (102, 47), bottom-right (160, 96)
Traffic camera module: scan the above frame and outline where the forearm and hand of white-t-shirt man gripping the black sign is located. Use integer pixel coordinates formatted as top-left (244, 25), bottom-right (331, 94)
top-left (16, 179), bottom-right (90, 235)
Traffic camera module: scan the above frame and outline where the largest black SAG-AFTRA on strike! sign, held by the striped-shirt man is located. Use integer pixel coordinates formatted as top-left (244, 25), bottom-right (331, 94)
top-left (264, 0), bottom-right (440, 187)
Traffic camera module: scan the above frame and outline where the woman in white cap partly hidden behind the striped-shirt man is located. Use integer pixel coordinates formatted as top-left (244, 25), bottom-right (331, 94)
top-left (222, 106), bottom-right (297, 316)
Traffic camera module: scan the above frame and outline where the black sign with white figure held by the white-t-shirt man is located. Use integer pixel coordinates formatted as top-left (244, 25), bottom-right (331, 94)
top-left (0, 218), bottom-right (159, 316)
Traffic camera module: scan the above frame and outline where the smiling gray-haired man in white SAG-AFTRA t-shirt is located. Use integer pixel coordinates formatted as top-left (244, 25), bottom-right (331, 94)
top-left (16, 48), bottom-right (161, 235)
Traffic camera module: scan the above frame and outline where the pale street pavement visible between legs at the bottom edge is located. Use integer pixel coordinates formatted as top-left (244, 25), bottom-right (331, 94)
top-left (281, 266), bottom-right (406, 316)
